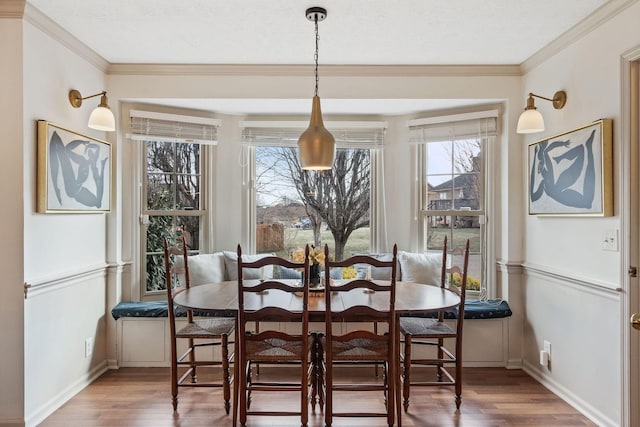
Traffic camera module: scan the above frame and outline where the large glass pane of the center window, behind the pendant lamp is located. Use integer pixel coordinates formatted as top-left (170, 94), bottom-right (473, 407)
top-left (255, 147), bottom-right (371, 258)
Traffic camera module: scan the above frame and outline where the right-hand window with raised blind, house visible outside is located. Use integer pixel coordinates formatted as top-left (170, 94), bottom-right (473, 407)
top-left (409, 111), bottom-right (497, 297)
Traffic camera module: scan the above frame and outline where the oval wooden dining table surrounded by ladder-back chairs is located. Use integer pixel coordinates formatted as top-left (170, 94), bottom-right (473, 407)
top-left (174, 280), bottom-right (460, 426)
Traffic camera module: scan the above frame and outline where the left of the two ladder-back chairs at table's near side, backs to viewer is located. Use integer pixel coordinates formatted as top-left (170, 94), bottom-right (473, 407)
top-left (236, 245), bottom-right (314, 426)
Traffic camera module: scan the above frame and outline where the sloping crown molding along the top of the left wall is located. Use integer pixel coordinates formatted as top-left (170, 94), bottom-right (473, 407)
top-left (22, 0), bottom-right (109, 73)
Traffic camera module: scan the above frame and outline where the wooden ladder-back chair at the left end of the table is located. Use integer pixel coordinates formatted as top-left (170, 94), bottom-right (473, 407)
top-left (164, 237), bottom-right (235, 415)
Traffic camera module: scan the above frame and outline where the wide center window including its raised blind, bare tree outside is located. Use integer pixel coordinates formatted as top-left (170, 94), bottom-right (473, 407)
top-left (243, 123), bottom-right (384, 259)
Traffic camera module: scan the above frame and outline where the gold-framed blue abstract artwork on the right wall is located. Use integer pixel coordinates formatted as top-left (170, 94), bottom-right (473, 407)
top-left (528, 119), bottom-right (613, 216)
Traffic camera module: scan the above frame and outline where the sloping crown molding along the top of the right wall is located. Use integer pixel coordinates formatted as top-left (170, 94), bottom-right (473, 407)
top-left (520, 0), bottom-right (638, 74)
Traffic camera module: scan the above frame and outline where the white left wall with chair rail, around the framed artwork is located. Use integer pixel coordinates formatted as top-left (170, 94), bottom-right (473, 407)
top-left (18, 15), bottom-right (107, 425)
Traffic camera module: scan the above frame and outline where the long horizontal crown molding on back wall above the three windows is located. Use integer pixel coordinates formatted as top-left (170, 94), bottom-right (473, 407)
top-left (107, 63), bottom-right (521, 77)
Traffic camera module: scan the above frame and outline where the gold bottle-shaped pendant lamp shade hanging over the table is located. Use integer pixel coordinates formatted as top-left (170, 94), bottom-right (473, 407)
top-left (298, 95), bottom-right (336, 170)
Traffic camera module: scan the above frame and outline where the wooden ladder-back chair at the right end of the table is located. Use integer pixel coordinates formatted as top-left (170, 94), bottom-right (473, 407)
top-left (400, 237), bottom-right (469, 412)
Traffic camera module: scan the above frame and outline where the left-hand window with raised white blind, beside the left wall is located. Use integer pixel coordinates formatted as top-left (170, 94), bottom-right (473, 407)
top-left (127, 110), bottom-right (218, 298)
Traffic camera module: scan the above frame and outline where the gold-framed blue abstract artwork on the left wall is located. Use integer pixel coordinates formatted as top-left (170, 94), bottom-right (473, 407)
top-left (36, 120), bottom-right (111, 213)
